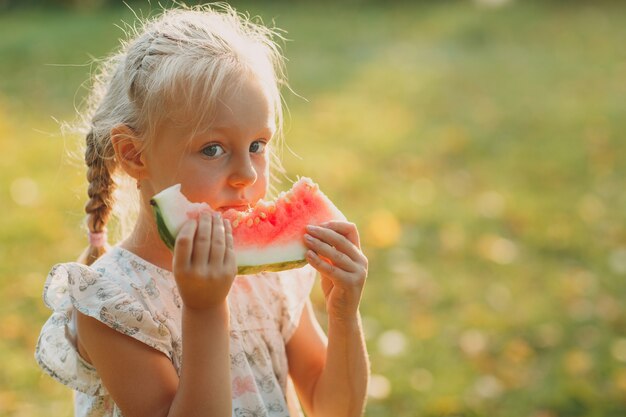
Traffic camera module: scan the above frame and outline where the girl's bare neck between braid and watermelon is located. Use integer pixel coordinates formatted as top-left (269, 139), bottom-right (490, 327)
top-left (120, 209), bottom-right (173, 271)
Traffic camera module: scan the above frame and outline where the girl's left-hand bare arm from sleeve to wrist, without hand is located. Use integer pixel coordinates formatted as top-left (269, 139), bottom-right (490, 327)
top-left (77, 302), bottom-right (232, 417)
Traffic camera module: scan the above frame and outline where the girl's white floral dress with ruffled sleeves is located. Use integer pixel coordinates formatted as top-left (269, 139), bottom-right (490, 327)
top-left (35, 247), bottom-right (315, 417)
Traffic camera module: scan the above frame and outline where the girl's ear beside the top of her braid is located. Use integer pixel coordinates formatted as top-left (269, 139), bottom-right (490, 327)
top-left (111, 124), bottom-right (146, 180)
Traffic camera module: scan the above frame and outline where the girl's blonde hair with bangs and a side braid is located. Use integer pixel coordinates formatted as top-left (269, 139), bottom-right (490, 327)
top-left (79, 3), bottom-right (286, 265)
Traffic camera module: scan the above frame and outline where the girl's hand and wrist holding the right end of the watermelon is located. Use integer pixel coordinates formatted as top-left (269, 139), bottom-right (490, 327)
top-left (304, 221), bottom-right (368, 320)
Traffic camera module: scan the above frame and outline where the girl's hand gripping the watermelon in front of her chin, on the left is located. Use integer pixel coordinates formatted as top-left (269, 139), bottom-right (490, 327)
top-left (172, 213), bottom-right (237, 310)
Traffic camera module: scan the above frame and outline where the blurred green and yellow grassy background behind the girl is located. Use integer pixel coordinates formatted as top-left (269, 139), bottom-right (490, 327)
top-left (0, 0), bottom-right (626, 417)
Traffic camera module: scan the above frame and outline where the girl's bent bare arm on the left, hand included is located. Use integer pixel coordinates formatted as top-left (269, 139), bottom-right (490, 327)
top-left (77, 213), bottom-right (237, 417)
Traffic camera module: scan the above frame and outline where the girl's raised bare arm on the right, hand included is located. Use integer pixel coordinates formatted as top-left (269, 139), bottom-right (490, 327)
top-left (287, 222), bottom-right (369, 417)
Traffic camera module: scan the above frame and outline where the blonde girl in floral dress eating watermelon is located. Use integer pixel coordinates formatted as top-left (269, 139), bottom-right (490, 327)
top-left (36, 6), bottom-right (368, 417)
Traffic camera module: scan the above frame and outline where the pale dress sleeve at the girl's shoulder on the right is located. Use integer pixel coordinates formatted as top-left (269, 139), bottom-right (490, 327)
top-left (280, 265), bottom-right (317, 343)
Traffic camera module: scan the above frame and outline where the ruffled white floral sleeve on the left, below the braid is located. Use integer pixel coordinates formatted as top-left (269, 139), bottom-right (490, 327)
top-left (35, 263), bottom-right (173, 396)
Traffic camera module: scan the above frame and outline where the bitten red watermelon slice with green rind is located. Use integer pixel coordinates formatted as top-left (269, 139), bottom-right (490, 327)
top-left (150, 178), bottom-right (346, 275)
